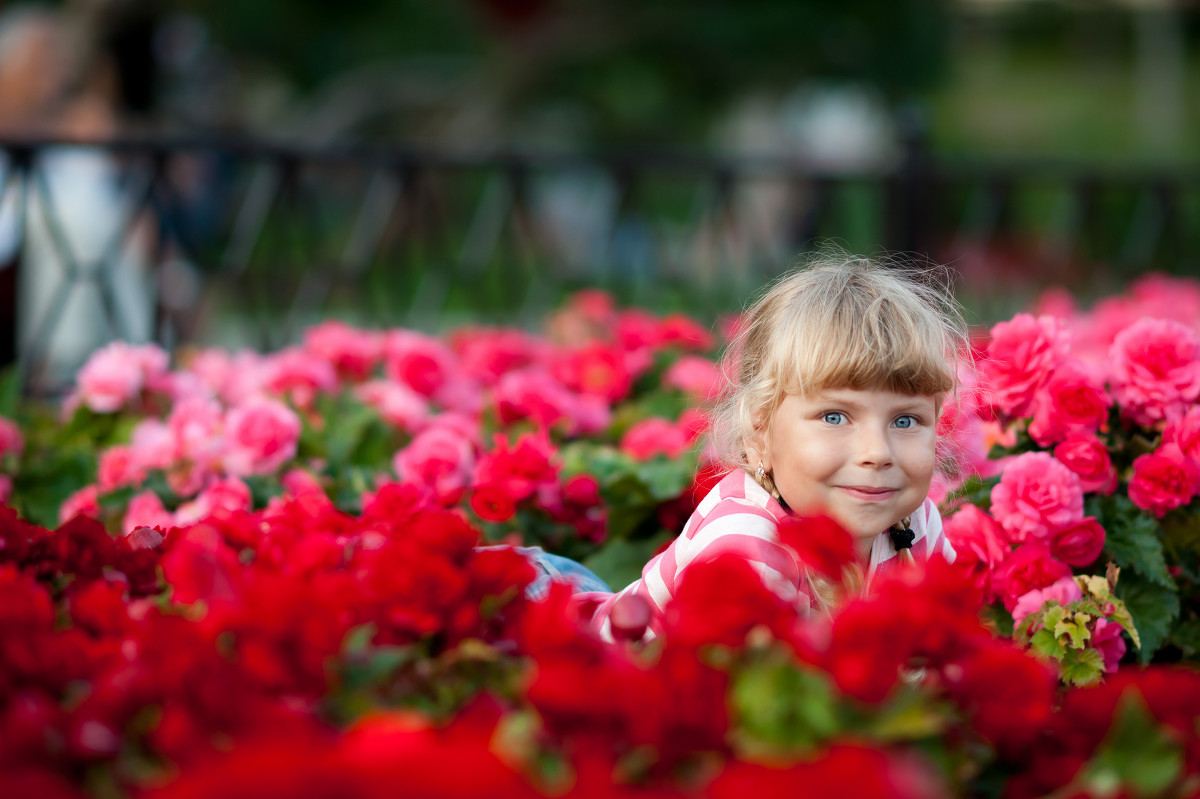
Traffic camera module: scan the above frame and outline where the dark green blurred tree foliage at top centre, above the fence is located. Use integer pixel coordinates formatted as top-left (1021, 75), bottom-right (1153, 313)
top-left (179, 0), bottom-right (949, 144)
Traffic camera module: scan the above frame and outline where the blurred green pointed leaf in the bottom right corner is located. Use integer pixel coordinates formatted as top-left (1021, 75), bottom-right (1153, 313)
top-left (1085, 691), bottom-right (1183, 797)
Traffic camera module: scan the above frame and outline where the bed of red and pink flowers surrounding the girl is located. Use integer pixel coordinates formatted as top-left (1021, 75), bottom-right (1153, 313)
top-left (0, 278), bottom-right (1200, 797)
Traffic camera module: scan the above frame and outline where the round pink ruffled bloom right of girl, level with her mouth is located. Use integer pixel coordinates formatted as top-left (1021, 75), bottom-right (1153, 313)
top-left (991, 452), bottom-right (1084, 542)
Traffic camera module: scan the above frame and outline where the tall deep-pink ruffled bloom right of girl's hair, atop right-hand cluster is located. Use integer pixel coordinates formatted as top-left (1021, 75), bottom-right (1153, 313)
top-left (979, 313), bottom-right (1070, 417)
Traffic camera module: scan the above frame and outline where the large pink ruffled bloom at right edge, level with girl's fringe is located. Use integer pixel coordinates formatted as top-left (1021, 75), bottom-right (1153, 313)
top-left (1109, 319), bottom-right (1200, 427)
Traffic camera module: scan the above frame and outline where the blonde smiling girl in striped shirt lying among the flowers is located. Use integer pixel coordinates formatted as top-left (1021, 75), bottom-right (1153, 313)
top-left (578, 258), bottom-right (967, 639)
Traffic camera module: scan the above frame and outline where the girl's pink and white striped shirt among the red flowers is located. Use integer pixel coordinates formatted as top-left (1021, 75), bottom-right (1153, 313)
top-left (577, 469), bottom-right (955, 641)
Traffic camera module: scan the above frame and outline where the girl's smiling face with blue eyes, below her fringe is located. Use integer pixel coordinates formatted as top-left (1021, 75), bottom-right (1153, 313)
top-left (750, 389), bottom-right (938, 552)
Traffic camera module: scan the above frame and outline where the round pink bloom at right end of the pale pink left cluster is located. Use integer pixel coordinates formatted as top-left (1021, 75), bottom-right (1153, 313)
top-left (223, 398), bottom-right (301, 476)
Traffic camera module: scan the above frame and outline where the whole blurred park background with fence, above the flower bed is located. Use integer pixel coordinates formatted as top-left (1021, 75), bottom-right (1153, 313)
top-left (0, 0), bottom-right (1200, 389)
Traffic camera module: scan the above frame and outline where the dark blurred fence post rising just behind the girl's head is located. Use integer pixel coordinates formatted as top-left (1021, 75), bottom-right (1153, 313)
top-left (884, 106), bottom-right (937, 258)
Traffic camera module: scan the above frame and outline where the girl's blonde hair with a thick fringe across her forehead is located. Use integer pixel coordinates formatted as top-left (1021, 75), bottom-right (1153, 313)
top-left (712, 255), bottom-right (968, 606)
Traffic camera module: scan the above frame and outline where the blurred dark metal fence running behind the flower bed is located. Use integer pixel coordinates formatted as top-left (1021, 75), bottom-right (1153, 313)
top-left (0, 135), bottom-right (1200, 391)
